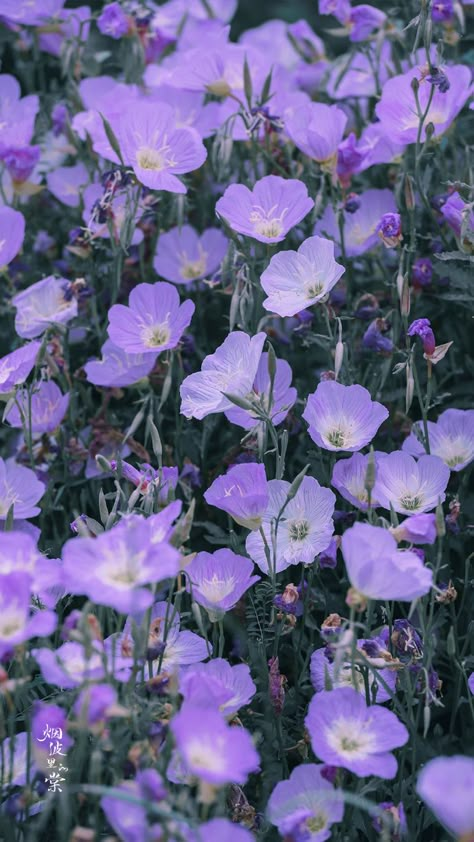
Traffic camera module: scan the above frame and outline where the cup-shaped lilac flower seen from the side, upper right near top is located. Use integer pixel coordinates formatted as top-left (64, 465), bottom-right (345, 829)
top-left (285, 102), bottom-right (347, 172)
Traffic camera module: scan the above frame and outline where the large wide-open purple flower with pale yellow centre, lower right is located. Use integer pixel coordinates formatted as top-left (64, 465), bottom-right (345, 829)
top-left (306, 687), bottom-right (409, 779)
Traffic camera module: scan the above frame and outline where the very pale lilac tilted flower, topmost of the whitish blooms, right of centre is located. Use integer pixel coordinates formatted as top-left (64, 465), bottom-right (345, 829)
top-left (260, 237), bottom-right (345, 316)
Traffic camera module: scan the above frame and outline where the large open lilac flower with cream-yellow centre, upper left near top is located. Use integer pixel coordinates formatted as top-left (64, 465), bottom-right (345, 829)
top-left (114, 102), bottom-right (207, 193)
